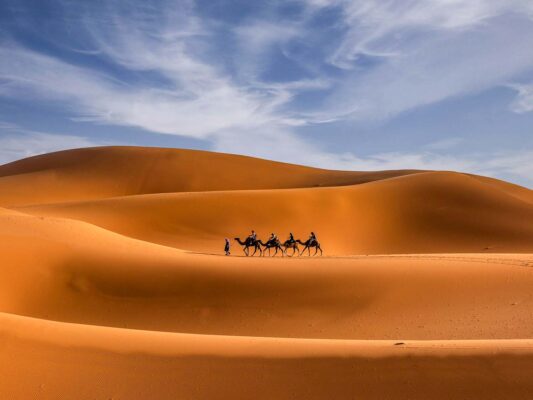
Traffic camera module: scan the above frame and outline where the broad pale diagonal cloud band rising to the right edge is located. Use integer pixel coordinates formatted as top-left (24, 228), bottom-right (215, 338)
top-left (320, 16), bottom-right (533, 120)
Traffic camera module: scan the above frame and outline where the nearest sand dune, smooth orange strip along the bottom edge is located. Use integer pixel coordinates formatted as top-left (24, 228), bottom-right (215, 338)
top-left (0, 314), bottom-right (533, 399)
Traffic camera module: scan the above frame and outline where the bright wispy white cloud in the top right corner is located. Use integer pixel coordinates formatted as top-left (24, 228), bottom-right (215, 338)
top-left (310, 0), bottom-right (533, 68)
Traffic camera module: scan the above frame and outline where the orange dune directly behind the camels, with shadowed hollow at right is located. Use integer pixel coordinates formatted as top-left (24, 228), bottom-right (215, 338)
top-left (15, 172), bottom-right (533, 255)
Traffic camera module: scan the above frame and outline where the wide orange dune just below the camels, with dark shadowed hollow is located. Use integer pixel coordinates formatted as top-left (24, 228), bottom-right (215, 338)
top-left (0, 209), bottom-right (533, 339)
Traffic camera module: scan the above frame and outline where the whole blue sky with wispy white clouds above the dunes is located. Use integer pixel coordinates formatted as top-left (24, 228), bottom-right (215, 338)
top-left (0, 0), bottom-right (533, 188)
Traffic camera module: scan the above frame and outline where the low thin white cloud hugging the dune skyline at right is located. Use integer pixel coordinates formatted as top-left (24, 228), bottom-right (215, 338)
top-left (214, 122), bottom-right (533, 187)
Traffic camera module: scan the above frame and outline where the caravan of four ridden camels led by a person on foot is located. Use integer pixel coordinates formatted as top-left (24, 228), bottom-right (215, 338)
top-left (225, 231), bottom-right (322, 257)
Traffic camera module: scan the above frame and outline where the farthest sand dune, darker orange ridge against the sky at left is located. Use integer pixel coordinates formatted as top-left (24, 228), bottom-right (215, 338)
top-left (0, 147), bottom-right (417, 206)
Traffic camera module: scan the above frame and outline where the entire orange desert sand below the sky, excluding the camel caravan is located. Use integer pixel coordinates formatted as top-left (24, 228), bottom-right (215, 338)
top-left (0, 147), bottom-right (533, 400)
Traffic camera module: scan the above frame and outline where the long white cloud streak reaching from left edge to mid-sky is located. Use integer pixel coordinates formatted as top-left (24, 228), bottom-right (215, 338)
top-left (0, 47), bottom-right (275, 137)
